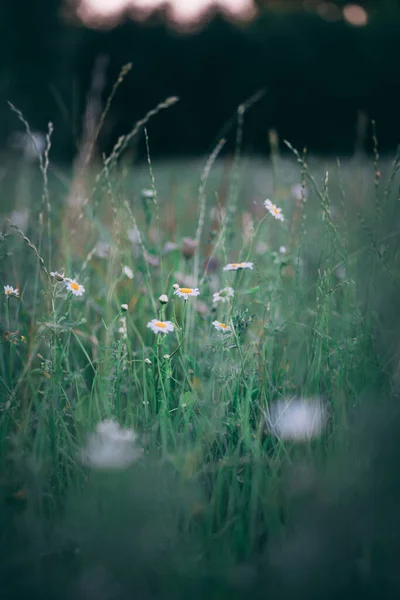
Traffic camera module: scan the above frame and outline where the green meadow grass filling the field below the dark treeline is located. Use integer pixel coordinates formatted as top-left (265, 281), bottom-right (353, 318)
top-left (0, 139), bottom-right (400, 599)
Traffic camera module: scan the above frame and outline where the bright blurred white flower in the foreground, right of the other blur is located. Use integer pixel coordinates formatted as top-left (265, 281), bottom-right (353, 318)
top-left (264, 397), bottom-right (327, 441)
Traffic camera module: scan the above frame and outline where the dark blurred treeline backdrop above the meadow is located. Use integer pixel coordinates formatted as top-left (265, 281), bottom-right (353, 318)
top-left (0, 0), bottom-right (400, 161)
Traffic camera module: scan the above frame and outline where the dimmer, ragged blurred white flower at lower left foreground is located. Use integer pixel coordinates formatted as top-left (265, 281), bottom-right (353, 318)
top-left (81, 419), bottom-right (141, 469)
